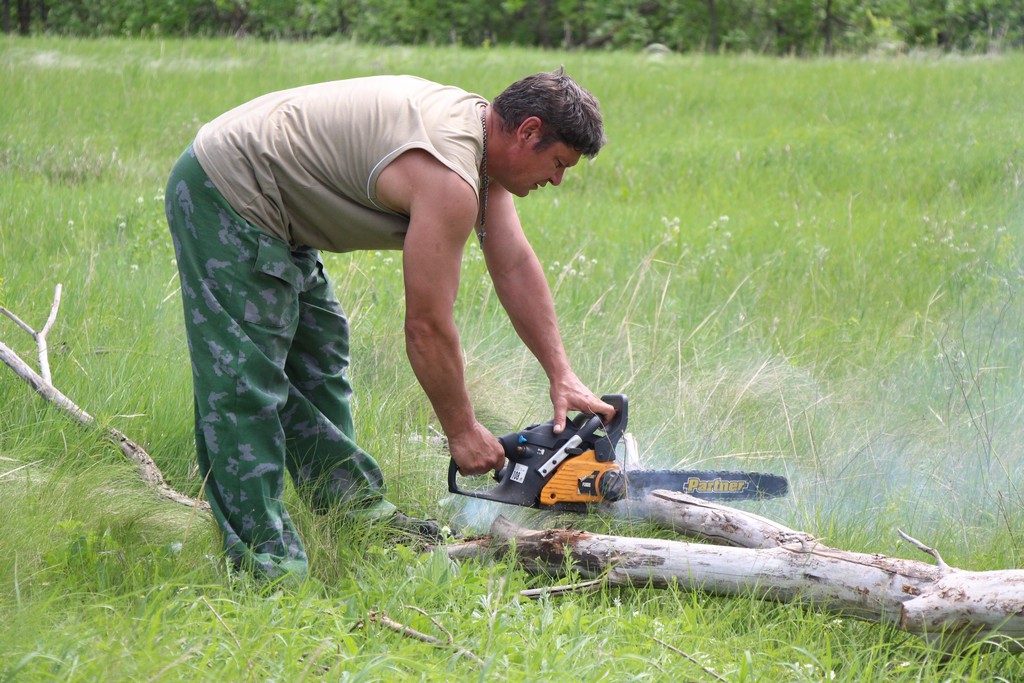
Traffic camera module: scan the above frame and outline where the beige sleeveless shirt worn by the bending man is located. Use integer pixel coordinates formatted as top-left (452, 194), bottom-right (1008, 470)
top-left (194, 76), bottom-right (486, 252)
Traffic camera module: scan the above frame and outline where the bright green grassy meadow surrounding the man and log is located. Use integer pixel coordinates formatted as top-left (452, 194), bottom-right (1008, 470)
top-left (0, 38), bottom-right (1024, 681)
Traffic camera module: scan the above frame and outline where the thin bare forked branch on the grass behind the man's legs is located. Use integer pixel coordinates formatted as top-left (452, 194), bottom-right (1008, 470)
top-left (0, 285), bottom-right (210, 510)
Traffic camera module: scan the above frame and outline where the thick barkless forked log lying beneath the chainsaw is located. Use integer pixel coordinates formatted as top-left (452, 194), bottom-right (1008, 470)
top-left (449, 490), bottom-right (1024, 652)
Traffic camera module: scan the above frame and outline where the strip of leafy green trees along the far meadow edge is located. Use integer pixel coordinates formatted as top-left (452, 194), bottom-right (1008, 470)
top-left (6, 0), bottom-right (1024, 55)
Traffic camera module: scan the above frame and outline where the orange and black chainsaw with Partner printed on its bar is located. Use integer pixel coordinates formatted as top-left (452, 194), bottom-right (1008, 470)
top-left (449, 394), bottom-right (788, 512)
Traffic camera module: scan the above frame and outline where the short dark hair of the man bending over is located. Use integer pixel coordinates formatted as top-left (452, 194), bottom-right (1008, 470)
top-left (492, 67), bottom-right (605, 158)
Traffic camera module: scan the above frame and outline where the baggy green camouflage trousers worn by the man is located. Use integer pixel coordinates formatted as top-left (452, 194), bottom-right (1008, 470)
top-left (166, 146), bottom-right (393, 578)
